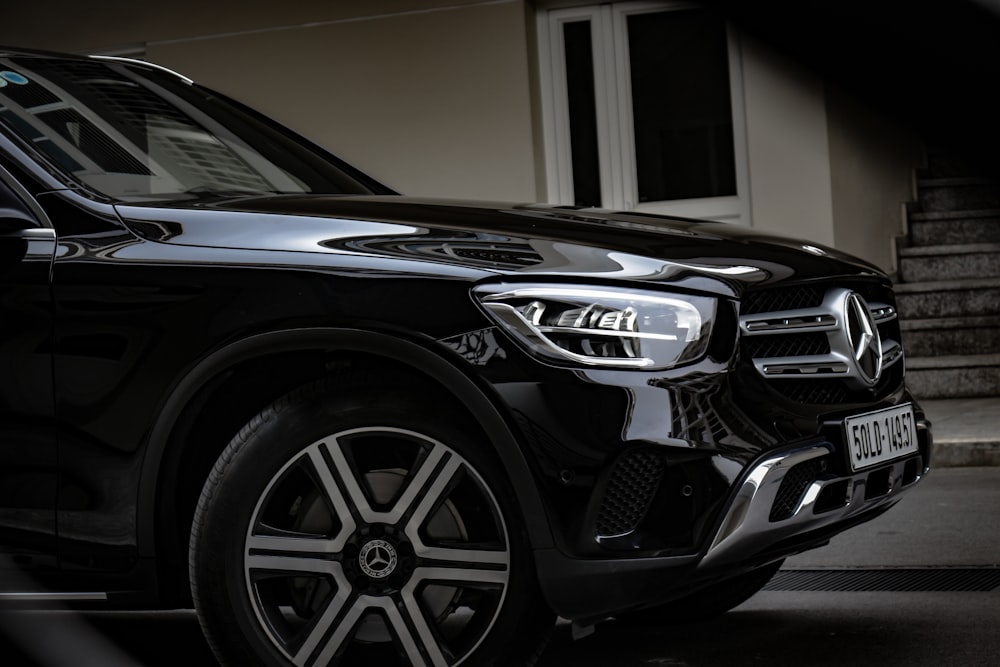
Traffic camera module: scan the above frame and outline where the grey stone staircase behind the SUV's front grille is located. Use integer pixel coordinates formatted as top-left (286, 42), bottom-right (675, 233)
top-left (896, 159), bottom-right (1000, 399)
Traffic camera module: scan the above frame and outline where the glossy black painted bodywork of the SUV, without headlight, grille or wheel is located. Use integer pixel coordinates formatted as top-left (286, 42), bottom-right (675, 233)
top-left (0, 48), bottom-right (920, 628)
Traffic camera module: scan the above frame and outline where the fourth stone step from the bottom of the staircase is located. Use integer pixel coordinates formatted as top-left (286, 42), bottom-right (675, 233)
top-left (899, 243), bottom-right (1000, 282)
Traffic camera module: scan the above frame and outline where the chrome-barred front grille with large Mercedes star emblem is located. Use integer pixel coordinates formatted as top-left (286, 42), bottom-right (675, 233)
top-left (740, 284), bottom-right (903, 404)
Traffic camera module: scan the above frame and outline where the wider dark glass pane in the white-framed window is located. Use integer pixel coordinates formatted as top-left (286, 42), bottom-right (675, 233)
top-left (628, 11), bottom-right (736, 202)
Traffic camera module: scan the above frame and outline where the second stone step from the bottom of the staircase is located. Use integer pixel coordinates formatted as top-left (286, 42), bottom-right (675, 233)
top-left (900, 315), bottom-right (1000, 357)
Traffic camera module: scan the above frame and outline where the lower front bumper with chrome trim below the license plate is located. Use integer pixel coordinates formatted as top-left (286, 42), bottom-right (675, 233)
top-left (535, 418), bottom-right (933, 622)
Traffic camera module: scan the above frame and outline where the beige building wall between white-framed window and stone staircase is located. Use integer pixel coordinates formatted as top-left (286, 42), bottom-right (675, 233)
top-left (742, 34), bottom-right (923, 272)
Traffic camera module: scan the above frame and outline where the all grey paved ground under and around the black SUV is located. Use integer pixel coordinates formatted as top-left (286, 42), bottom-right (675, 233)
top-left (0, 467), bottom-right (1000, 667)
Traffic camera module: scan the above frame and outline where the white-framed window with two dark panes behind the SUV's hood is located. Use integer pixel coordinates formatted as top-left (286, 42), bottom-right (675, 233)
top-left (540, 2), bottom-right (749, 223)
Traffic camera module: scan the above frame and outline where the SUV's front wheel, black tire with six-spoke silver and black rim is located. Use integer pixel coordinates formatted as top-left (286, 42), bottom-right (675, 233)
top-left (184, 381), bottom-right (554, 667)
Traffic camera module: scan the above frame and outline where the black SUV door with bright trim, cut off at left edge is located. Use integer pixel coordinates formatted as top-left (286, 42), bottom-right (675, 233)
top-left (0, 159), bottom-right (58, 580)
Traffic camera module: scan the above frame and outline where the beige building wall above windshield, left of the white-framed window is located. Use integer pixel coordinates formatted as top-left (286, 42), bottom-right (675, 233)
top-left (0, 0), bottom-right (538, 201)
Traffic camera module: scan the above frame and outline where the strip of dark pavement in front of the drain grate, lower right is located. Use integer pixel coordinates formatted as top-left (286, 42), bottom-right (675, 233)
top-left (539, 591), bottom-right (1000, 667)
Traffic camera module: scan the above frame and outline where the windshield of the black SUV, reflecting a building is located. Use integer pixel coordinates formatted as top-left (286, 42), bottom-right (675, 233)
top-left (0, 56), bottom-right (389, 201)
